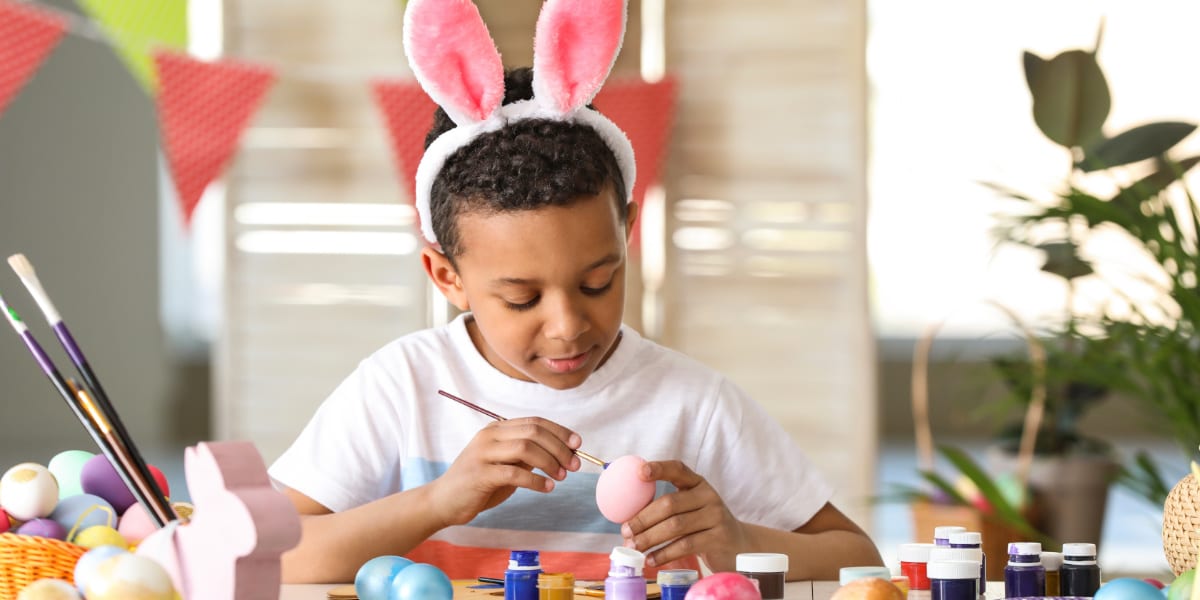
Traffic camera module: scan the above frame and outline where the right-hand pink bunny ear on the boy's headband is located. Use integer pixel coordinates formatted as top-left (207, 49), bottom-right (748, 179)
top-left (533, 0), bottom-right (625, 114)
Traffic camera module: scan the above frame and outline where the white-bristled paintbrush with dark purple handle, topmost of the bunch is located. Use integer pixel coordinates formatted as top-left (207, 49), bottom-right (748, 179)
top-left (8, 254), bottom-right (175, 527)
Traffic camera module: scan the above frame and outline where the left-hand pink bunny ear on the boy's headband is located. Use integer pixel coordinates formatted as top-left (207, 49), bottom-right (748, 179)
top-left (404, 0), bottom-right (504, 125)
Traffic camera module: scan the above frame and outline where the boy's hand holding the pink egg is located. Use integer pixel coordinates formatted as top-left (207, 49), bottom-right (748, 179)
top-left (620, 461), bottom-right (748, 571)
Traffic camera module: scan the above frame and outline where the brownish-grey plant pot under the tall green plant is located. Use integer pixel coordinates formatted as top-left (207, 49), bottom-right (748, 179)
top-left (986, 446), bottom-right (1118, 544)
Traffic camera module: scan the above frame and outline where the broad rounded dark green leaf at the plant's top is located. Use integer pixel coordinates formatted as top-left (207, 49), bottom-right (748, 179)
top-left (1025, 50), bottom-right (1112, 148)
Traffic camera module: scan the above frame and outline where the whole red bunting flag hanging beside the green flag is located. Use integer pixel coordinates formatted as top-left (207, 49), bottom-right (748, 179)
top-left (154, 52), bottom-right (275, 223)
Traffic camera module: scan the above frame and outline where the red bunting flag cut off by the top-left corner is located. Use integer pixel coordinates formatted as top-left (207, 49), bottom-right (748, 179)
top-left (0, 1), bottom-right (67, 115)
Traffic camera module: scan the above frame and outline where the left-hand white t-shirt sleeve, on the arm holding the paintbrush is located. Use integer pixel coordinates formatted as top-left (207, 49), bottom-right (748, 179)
top-left (268, 361), bottom-right (402, 512)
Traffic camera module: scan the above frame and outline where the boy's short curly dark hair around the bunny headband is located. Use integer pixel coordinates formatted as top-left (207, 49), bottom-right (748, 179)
top-left (425, 67), bottom-right (629, 259)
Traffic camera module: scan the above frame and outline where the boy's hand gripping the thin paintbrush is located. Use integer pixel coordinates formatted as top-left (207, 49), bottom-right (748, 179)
top-left (430, 416), bottom-right (582, 527)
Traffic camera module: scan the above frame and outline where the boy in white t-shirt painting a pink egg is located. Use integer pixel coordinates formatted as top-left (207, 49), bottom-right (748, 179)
top-left (270, 0), bottom-right (882, 582)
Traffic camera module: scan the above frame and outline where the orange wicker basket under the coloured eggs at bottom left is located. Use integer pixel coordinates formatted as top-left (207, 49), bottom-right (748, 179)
top-left (0, 533), bottom-right (88, 600)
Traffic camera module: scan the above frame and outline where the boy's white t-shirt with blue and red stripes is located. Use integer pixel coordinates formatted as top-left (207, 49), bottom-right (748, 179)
top-left (270, 314), bottom-right (833, 578)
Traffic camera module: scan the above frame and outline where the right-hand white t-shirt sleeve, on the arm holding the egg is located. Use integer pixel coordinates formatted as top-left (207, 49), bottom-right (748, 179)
top-left (698, 380), bottom-right (833, 532)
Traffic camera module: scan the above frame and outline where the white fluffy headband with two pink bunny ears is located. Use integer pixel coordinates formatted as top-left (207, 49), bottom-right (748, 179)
top-left (404, 0), bottom-right (636, 245)
